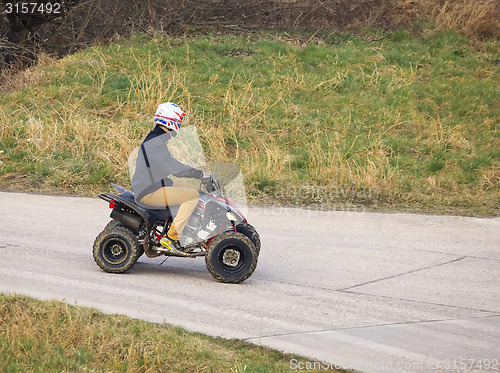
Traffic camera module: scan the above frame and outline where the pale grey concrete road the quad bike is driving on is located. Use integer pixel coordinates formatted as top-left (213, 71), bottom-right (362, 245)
top-left (0, 193), bottom-right (500, 372)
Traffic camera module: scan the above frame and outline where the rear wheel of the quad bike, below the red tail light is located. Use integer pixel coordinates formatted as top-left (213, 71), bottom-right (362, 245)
top-left (93, 226), bottom-right (140, 273)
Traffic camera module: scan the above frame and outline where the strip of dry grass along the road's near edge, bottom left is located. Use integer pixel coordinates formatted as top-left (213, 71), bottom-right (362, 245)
top-left (0, 293), bottom-right (340, 373)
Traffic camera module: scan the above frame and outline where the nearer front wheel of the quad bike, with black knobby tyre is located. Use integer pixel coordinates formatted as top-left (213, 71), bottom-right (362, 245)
top-left (205, 232), bottom-right (258, 284)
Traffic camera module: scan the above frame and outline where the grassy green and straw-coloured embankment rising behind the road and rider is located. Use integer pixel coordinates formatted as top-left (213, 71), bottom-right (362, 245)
top-left (0, 31), bottom-right (500, 215)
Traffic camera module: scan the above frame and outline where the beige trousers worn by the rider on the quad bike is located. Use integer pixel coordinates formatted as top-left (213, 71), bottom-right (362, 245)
top-left (141, 182), bottom-right (199, 241)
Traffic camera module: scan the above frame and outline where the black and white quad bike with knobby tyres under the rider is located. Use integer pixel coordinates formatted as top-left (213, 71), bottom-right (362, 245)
top-left (93, 174), bottom-right (261, 283)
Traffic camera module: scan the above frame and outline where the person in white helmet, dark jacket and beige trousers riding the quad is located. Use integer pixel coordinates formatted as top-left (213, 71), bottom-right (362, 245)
top-left (132, 102), bottom-right (203, 252)
